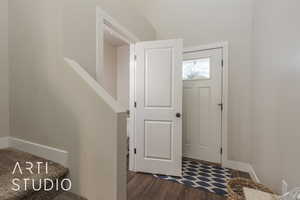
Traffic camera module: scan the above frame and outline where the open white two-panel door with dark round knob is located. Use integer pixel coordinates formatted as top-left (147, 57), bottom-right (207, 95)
top-left (135, 40), bottom-right (182, 176)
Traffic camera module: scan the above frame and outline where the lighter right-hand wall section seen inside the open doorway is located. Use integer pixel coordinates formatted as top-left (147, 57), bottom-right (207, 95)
top-left (117, 45), bottom-right (130, 110)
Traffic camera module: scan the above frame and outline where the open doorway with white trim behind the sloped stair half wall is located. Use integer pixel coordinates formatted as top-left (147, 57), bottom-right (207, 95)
top-left (96, 8), bottom-right (139, 173)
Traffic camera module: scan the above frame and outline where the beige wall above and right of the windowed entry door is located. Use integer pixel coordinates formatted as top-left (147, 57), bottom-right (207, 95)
top-left (132, 0), bottom-right (252, 162)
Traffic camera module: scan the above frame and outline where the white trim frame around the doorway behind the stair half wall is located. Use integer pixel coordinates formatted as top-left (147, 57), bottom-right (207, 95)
top-left (96, 6), bottom-right (141, 171)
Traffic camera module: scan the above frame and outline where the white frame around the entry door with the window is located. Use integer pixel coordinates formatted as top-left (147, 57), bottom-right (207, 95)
top-left (183, 41), bottom-right (229, 166)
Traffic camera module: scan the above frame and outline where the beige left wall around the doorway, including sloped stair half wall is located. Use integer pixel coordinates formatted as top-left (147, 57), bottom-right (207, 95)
top-left (9, 0), bottom-right (154, 200)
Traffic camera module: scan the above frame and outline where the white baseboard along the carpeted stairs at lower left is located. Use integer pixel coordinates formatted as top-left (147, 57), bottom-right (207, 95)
top-left (8, 137), bottom-right (68, 167)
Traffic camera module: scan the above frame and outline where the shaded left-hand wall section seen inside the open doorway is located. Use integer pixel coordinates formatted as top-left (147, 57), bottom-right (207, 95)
top-left (100, 40), bottom-right (118, 99)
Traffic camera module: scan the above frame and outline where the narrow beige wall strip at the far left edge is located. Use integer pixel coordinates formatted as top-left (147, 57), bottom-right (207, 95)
top-left (0, 0), bottom-right (9, 138)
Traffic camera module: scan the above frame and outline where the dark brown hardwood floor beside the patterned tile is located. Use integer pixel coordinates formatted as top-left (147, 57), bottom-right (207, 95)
top-left (127, 161), bottom-right (250, 200)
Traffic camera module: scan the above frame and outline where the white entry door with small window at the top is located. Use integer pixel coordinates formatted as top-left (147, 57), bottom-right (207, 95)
top-left (183, 49), bottom-right (222, 163)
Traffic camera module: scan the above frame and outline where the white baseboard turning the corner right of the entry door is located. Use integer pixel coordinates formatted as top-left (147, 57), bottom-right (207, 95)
top-left (222, 160), bottom-right (260, 183)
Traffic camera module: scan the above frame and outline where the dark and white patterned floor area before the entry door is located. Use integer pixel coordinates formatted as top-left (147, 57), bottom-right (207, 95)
top-left (154, 160), bottom-right (232, 196)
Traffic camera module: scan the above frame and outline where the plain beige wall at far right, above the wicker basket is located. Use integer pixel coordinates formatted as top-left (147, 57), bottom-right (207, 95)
top-left (251, 0), bottom-right (300, 192)
